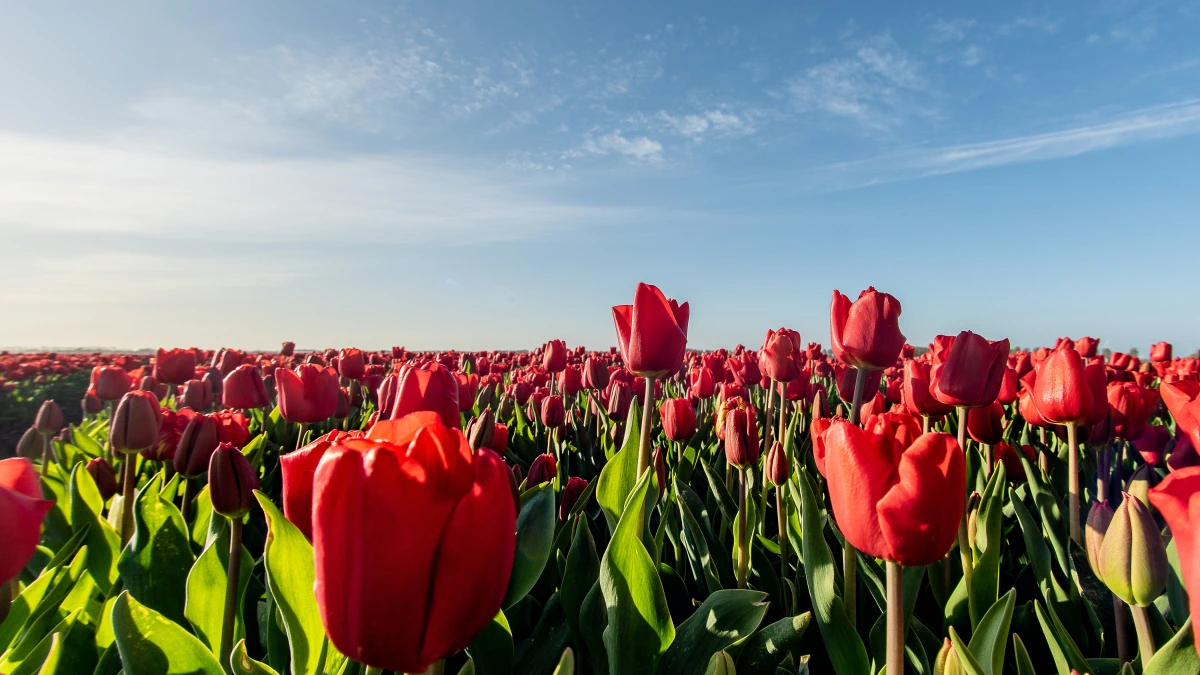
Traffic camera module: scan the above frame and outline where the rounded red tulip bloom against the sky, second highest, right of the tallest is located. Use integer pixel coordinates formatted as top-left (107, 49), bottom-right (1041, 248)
top-left (829, 286), bottom-right (905, 370)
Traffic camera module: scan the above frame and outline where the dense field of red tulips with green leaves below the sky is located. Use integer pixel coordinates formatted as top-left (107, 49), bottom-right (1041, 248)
top-left (0, 283), bottom-right (1200, 675)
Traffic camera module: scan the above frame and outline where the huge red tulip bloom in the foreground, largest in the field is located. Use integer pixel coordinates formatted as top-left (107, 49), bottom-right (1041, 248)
top-left (313, 412), bottom-right (516, 673)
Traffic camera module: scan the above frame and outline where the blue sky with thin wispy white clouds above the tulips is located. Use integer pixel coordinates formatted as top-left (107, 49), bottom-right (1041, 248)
top-left (0, 0), bottom-right (1200, 352)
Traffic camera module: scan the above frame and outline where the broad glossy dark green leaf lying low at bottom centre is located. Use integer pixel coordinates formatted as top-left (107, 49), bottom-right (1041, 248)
top-left (658, 590), bottom-right (767, 675)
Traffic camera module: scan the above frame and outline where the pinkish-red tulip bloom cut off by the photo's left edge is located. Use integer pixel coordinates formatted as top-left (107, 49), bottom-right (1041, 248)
top-left (0, 458), bottom-right (54, 584)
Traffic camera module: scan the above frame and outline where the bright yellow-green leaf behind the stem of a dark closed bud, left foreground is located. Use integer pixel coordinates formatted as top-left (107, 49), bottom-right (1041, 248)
top-left (184, 518), bottom-right (254, 653)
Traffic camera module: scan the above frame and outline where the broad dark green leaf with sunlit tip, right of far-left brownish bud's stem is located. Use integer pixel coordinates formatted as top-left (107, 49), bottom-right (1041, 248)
top-left (116, 470), bottom-right (196, 623)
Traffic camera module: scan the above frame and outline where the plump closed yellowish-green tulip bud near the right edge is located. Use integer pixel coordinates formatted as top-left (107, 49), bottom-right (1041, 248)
top-left (1097, 492), bottom-right (1166, 607)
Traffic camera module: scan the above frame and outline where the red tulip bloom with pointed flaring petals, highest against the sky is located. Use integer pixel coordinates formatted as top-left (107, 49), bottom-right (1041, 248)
top-left (612, 283), bottom-right (689, 377)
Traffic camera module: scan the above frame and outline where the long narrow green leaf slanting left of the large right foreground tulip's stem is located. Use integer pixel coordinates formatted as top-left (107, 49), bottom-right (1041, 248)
top-left (788, 468), bottom-right (871, 675)
